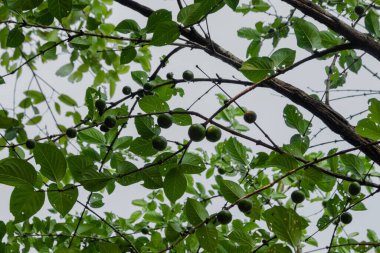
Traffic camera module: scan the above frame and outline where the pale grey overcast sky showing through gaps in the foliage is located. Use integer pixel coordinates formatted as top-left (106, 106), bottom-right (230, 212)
top-left (0, 0), bottom-right (380, 251)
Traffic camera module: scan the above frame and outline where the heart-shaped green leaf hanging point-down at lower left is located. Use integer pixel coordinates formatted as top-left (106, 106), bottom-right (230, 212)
top-left (47, 184), bottom-right (78, 216)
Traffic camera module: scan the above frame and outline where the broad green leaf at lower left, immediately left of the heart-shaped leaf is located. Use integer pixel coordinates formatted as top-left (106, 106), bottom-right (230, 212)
top-left (9, 187), bottom-right (45, 223)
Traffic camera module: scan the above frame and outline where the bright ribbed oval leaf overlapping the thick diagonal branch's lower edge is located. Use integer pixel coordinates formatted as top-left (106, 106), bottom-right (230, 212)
top-left (240, 57), bottom-right (274, 83)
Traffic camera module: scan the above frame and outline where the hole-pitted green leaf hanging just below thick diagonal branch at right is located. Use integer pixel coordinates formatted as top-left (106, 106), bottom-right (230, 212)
top-left (283, 105), bottom-right (312, 135)
